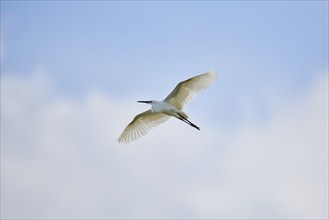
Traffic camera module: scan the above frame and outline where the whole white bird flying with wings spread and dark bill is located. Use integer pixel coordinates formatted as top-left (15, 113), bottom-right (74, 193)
top-left (118, 70), bottom-right (217, 144)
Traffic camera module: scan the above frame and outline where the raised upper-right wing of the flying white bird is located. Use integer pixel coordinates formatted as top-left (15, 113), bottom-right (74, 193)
top-left (164, 70), bottom-right (217, 109)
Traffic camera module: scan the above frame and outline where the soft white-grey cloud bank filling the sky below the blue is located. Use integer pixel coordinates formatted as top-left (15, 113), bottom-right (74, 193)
top-left (1, 71), bottom-right (328, 219)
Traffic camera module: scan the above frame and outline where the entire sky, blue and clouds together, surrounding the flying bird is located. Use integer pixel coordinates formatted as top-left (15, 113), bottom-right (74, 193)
top-left (1, 1), bottom-right (328, 218)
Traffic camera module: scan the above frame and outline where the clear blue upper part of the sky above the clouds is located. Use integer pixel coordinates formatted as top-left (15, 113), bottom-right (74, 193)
top-left (2, 1), bottom-right (328, 89)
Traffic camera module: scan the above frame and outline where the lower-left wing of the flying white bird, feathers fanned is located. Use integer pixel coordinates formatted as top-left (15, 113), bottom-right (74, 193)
top-left (118, 110), bottom-right (169, 144)
